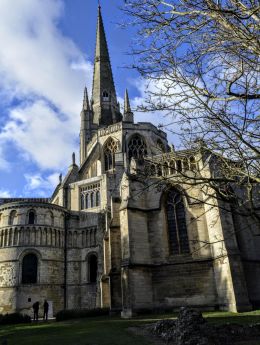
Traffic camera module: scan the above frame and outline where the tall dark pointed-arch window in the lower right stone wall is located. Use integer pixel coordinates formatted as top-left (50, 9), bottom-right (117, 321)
top-left (166, 188), bottom-right (190, 254)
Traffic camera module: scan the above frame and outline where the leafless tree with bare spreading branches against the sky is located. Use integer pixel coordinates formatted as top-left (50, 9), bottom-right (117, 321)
top-left (123, 0), bottom-right (260, 221)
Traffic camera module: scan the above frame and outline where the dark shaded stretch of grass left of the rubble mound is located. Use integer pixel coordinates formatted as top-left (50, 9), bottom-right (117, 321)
top-left (0, 318), bottom-right (156, 345)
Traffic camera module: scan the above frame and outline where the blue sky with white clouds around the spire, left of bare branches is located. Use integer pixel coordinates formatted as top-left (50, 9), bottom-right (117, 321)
top-left (0, 0), bottom-right (171, 197)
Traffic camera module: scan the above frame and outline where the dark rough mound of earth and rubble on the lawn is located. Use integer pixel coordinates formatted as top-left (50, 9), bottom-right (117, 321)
top-left (129, 308), bottom-right (260, 345)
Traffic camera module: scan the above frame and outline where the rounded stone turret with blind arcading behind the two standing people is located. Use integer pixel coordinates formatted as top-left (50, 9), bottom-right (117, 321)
top-left (0, 201), bottom-right (65, 314)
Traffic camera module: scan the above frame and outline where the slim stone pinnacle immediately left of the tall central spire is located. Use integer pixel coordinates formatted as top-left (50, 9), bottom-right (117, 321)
top-left (79, 87), bottom-right (92, 164)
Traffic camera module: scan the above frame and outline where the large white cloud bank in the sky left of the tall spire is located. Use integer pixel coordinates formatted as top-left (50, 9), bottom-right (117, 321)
top-left (0, 0), bottom-right (92, 169)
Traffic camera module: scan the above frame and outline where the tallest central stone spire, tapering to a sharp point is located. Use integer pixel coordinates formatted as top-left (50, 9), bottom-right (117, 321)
top-left (92, 5), bottom-right (122, 127)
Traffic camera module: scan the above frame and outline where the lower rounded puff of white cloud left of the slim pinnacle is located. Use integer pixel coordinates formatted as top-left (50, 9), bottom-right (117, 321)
top-left (1, 101), bottom-right (78, 169)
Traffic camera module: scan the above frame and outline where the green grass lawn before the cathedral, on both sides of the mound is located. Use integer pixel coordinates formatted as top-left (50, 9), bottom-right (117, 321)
top-left (0, 310), bottom-right (260, 345)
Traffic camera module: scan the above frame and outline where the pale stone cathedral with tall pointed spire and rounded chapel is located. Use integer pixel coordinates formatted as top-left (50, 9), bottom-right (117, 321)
top-left (0, 7), bottom-right (260, 317)
